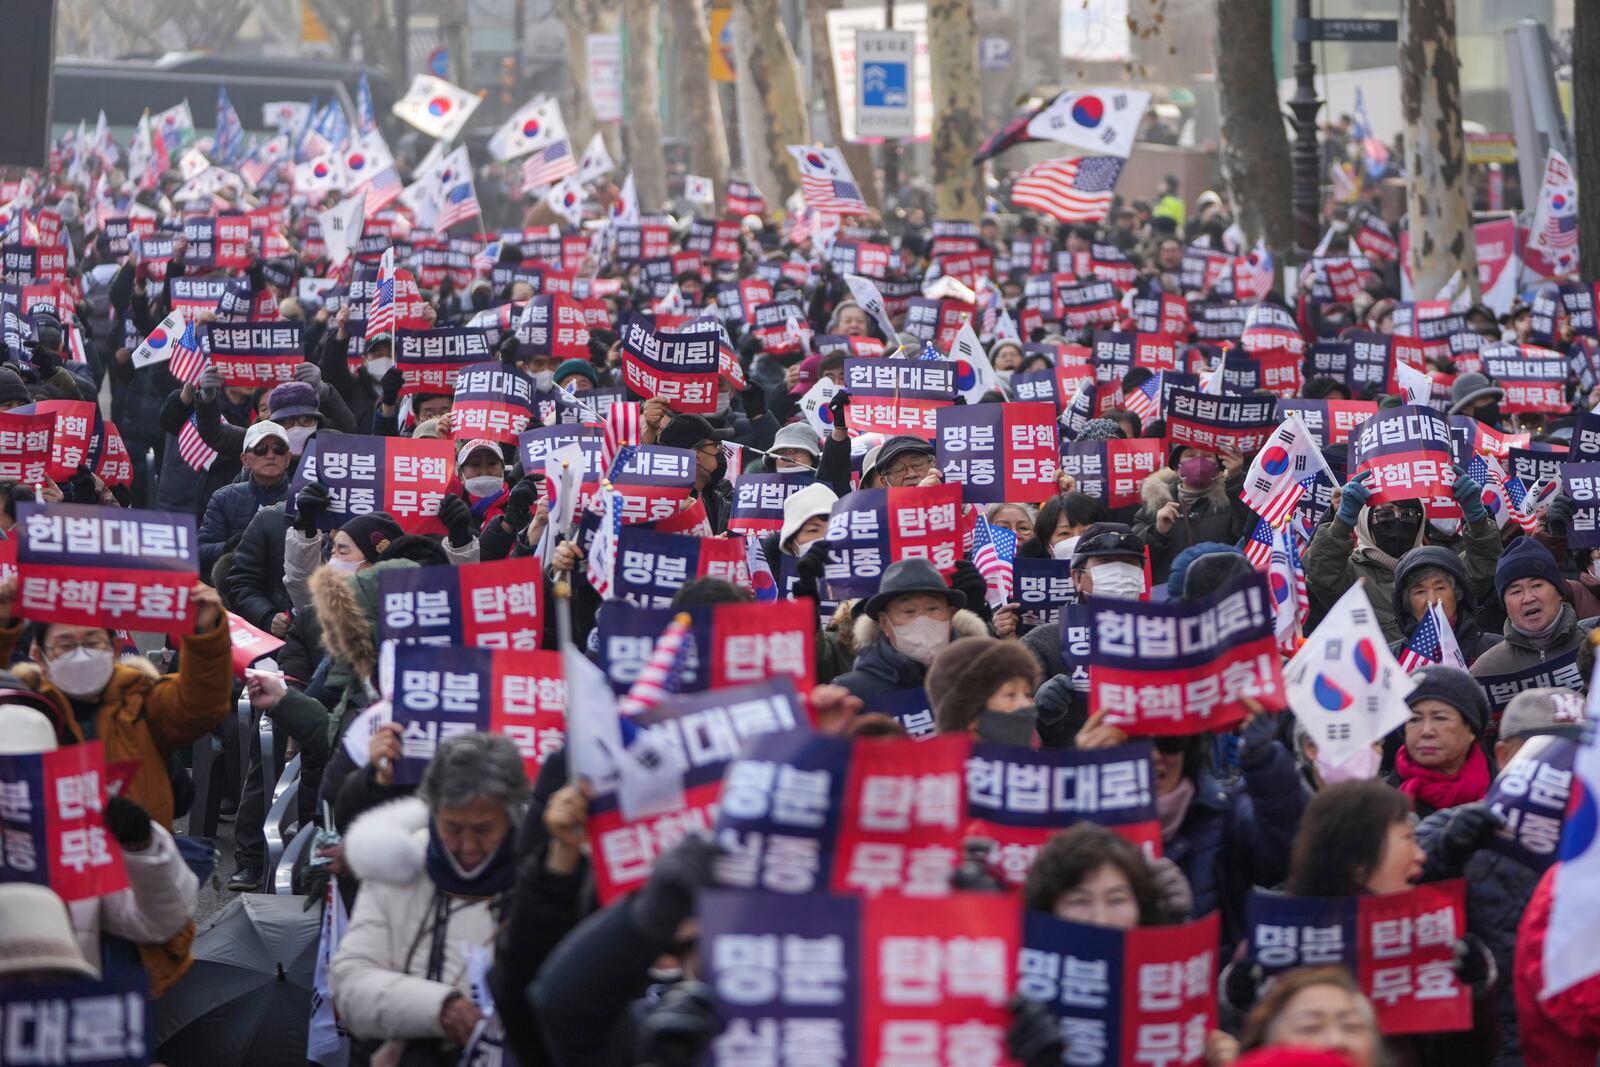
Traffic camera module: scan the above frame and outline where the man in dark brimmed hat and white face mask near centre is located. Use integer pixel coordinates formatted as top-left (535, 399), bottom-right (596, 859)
top-left (834, 560), bottom-right (989, 701)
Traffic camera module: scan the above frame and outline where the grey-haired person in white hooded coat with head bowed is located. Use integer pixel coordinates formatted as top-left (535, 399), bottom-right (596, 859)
top-left (330, 733), bottom-right (528, 1065)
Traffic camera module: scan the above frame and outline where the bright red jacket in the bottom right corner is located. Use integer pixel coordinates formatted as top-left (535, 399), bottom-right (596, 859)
top-left (1515, 864), bottom-right (1600, 1067)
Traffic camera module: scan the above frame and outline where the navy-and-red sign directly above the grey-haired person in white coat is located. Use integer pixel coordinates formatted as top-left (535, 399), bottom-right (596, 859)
top-left (387, 645), bottom-right (566, 784)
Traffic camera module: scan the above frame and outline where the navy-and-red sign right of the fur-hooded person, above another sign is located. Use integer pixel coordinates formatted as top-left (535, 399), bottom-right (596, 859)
top-left (378, 557), bottom-right (544, 651)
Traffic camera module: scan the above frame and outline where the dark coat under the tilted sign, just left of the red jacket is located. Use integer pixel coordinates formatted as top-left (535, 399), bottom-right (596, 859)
top-left (1416, 809), bottom-right (1539, 1067)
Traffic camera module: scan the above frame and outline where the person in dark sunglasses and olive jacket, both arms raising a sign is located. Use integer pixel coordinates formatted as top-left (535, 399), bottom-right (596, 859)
top-left (1304, 467), bottom-right (1501, 645)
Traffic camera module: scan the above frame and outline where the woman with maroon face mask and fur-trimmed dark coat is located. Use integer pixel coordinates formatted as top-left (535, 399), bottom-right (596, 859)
top-left (1133, 445), bottom-right (1254, 582)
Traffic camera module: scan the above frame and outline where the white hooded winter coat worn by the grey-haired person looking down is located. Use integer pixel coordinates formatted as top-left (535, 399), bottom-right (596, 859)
top-left (328, 797), bottom-right (496, 1041)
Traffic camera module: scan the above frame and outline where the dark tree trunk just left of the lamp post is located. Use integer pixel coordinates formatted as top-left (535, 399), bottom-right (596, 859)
top-left (1216, 0), bottom-right (1294, 251)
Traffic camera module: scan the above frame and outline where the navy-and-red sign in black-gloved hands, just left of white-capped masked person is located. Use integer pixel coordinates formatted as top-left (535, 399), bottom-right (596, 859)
top-left (290, 430), bottom-right (459, 533)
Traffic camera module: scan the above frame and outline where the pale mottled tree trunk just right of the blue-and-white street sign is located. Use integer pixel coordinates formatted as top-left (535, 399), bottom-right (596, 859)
top-left (928, 0), bottom-right (984, 222)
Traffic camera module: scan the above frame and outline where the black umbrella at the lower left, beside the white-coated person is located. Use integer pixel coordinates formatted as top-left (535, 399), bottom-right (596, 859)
top-left (154, 893), bottom-right (322, 1067)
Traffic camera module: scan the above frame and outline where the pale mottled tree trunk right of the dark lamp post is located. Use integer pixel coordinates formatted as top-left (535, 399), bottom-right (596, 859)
top-left (1400, 0), bottom-right (1478, 299)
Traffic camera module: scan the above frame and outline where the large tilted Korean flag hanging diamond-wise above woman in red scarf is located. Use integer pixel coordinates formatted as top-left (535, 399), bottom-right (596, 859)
top-left (1283, 579), bottom-right (1416, 766)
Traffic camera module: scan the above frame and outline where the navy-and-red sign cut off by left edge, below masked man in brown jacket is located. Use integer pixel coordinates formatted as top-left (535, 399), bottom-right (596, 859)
top-left (0, 741), bottom-right (128, 904)
